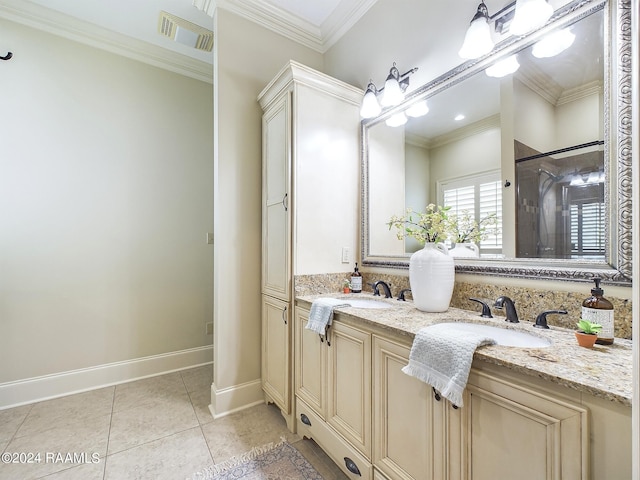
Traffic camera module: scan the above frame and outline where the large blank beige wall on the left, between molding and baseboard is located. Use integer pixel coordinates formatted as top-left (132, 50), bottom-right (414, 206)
top-left (0, 20), bottom-right (213, 384)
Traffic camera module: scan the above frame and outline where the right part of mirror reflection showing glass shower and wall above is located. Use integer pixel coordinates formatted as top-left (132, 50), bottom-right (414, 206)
top-left (513, 12), bottom-right (606, 260)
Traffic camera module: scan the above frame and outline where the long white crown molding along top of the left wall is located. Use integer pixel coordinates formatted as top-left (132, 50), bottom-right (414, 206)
top-left (0, 0), bottom-right (213, 84)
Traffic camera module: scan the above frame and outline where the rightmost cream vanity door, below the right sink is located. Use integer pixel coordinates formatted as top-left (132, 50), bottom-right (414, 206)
top-left (463, 371), bottom-right (589, 480)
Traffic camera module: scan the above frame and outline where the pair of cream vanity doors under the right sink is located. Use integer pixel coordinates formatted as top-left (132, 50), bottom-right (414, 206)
top-left (373, 337), bottom-right (589, 480)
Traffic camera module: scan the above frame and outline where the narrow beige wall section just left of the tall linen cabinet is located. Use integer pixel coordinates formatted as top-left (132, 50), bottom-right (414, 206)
top-left (212, 8), bottom-right (322, 415)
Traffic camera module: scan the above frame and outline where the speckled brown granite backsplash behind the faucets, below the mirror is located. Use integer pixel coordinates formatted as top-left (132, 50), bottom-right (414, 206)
top-left (294, 271), bottom-right (631, 339)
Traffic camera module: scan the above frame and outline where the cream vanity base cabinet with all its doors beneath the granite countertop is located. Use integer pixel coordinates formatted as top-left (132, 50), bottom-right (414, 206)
top-left (294, 305), bottom-right (631, 480)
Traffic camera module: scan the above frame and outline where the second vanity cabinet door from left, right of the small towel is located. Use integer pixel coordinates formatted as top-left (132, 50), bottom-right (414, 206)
top-left (326, 322), bottom-right (371, 459)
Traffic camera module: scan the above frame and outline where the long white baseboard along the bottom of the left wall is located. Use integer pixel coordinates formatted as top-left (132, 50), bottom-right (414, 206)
top-left (0, 345), bottom-right (213, 410)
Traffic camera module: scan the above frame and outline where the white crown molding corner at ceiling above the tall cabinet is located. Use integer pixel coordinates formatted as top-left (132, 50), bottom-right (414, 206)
top-left (212, 0), bottom-right (377, 53)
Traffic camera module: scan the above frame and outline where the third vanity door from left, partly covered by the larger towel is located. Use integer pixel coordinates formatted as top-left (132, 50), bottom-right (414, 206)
top-left (373, 336), bottom-right (432, 480)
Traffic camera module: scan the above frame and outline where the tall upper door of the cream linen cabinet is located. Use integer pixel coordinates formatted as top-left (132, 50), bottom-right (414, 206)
top-left (262, 93), bottom-right (291, 300)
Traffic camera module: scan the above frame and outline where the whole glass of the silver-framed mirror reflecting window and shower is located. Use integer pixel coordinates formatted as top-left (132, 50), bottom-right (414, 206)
top-left (362, 2), bottom-right (630, 284)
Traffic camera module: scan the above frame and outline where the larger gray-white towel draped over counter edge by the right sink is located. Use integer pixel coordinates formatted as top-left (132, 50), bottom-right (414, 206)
top-left (402, 324), bottom-right (496, 407)
